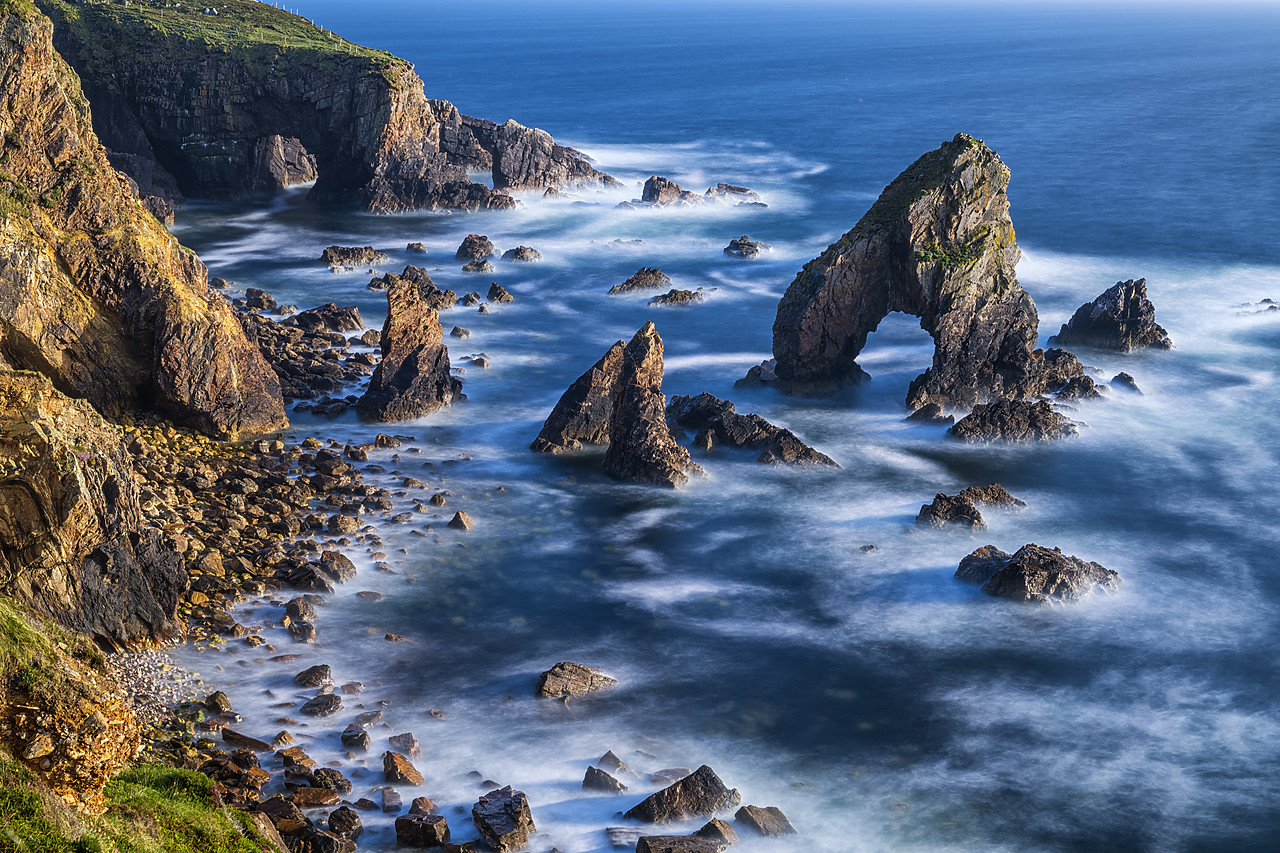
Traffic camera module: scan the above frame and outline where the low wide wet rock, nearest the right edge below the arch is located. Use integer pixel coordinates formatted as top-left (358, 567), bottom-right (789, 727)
top-left (955, 544), bottom-right (1120, 603)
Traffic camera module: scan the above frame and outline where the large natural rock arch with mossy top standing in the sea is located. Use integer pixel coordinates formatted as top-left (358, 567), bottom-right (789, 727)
top-left (757, 134), bottom-right (1038, 409)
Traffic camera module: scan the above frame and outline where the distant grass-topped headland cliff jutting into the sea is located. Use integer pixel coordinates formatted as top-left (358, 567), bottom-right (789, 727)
top-left (38, 0), bottom-right (612, 213)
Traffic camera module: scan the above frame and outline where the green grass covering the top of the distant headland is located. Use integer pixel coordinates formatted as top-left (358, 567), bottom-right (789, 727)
top-left (36, 0), bottom-right (406, 72)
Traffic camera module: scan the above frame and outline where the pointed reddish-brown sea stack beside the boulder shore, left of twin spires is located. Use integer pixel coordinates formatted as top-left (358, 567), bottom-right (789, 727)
top-left (356, 280), bottom-right (462, 421)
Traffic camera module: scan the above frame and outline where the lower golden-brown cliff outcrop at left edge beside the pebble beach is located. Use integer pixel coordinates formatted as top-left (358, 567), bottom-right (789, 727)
top-left (0, 371), bottom-right (187, 649)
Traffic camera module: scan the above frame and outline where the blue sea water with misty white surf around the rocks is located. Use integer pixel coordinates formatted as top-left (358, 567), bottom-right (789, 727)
top-left (167, 0), bottom-right (1280, 853)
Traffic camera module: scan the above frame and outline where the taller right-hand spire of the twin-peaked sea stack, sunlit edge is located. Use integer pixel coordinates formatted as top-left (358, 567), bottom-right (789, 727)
top-left (604, 323), bottom-right (703, 487)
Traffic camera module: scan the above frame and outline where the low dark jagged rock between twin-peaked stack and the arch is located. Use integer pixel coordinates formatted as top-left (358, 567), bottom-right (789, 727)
top-left (667, 392), bottom-right (840, 467)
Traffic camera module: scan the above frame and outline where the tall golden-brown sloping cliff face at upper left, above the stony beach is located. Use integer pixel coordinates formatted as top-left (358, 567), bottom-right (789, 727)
top-left (0, 8), bottom-right (287, 437)
